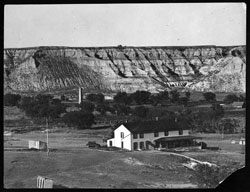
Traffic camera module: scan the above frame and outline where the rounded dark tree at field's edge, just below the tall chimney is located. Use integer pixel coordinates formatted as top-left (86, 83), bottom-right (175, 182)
top-left (62, 111), bottom-right (95, 129)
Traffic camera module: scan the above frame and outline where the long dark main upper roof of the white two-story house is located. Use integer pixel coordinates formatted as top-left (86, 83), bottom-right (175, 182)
top-left (123, 119), bottom-right (188, 133)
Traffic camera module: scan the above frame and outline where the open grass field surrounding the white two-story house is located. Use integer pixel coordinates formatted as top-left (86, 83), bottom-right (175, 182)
top-left (4, 108), bottom-right (245, 188)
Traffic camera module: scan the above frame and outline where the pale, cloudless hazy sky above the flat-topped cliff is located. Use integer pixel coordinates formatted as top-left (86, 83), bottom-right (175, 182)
top-left (4, 3), bottom-right (246, 48)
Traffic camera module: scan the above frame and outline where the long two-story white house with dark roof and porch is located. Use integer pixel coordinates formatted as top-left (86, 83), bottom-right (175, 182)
top-left (107, 119), bottom-right (201, 150)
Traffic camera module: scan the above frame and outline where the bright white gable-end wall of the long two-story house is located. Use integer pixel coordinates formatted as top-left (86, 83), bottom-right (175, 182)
top-left (107, 125), bottom-right (132, 150)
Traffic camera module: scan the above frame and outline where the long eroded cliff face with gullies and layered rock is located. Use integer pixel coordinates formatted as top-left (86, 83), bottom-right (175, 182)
top-left (4, 46), bottom-right (246, 92)
